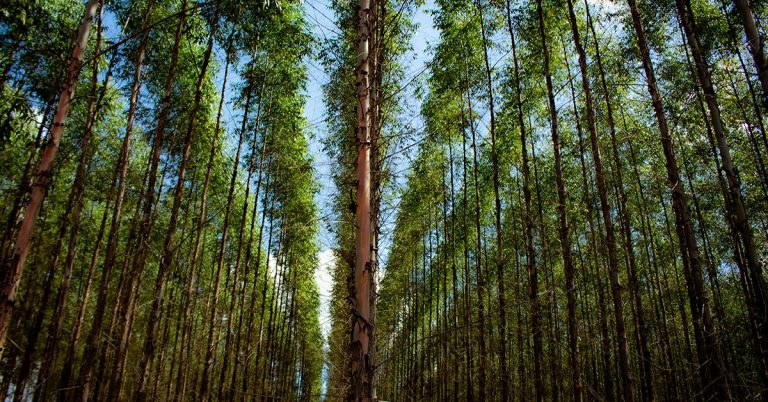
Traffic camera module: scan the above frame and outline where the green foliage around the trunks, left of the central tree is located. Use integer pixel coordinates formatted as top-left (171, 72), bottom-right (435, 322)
top-left (0, 0), bottom-right (323, 400)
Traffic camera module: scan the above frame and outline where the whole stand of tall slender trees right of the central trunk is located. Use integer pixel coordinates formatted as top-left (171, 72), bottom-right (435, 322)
top-left (330, 0), bottom-right (768, 401)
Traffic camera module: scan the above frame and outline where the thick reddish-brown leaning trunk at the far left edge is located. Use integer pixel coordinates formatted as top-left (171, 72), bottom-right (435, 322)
top-left (0, 0), bottom-right (99, 356)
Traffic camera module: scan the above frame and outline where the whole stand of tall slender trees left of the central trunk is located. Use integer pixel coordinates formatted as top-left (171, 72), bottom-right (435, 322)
top-left (0, 0), bottom-right (323, 400)
